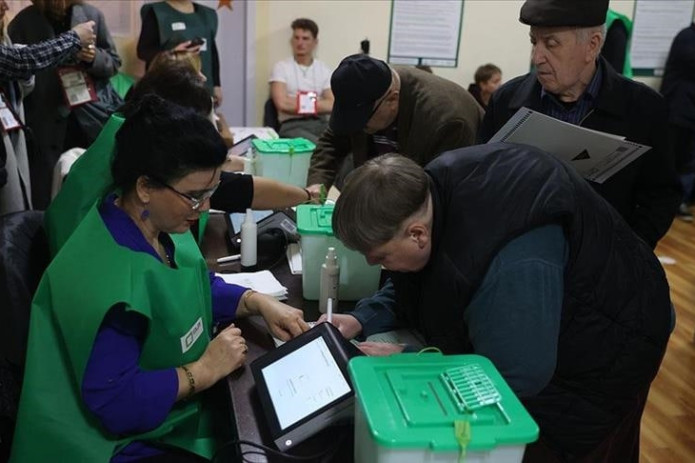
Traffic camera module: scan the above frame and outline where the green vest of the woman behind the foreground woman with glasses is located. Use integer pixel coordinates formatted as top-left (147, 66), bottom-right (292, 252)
top-left (44, 114), bottom-right (208, 256)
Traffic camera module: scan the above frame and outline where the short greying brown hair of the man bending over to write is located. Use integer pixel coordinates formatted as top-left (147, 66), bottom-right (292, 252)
top-left (333, 153), bottom-right (429, 254)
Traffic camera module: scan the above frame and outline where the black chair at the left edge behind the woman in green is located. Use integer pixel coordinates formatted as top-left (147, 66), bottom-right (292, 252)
top-left (0, 211), bottom-right (50, 461)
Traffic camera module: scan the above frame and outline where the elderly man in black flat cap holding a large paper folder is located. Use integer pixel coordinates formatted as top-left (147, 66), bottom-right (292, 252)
top-left (479, 0), bottom-right (681, 248)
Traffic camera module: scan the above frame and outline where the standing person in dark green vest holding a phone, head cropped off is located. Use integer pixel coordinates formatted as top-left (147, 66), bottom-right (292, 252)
top-left (137, 0), bottom-right (222, 106)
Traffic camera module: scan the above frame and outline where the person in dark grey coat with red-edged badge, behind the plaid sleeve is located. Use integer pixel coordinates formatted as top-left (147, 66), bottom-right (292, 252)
top-left (7, 0), bottom-right (123, 210)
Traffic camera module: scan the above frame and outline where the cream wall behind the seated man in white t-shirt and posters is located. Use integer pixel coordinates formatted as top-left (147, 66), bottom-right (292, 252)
top-left (254, 0), bottom-right (659, 122)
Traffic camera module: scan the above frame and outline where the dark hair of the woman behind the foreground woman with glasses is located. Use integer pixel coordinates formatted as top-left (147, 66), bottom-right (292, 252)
top-left (119, 60), bottom-right (212, 118)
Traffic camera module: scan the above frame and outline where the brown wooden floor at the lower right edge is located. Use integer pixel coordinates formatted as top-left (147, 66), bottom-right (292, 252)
top-left (640, 215), bottom-right (695, 463)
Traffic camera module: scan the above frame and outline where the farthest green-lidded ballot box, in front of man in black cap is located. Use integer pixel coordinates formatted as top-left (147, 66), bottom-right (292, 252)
top-left (251, 138), bottom-right (316, 188)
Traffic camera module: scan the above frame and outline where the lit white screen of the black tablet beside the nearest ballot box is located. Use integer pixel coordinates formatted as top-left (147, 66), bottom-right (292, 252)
top-left (261, 337), bottom-right (351, 429)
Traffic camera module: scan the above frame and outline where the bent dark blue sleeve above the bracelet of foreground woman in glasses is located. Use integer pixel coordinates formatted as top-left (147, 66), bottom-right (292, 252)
top-left (82, 305), bottom-right (179, 434)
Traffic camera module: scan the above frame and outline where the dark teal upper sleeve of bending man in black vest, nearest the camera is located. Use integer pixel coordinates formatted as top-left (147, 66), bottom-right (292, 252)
top-left (464, 225), bottom-right (568, 397)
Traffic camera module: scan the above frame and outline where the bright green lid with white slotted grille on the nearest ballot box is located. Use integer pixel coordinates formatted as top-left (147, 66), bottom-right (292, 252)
top-left (348, 353), bottom-right (538, 452)
